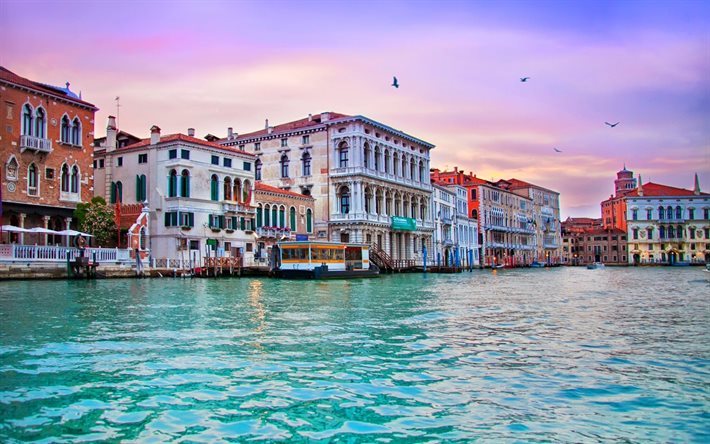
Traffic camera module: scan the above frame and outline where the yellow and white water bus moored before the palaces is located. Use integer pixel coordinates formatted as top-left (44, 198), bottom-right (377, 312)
top-left (274, 241), bottom-right (380, 279)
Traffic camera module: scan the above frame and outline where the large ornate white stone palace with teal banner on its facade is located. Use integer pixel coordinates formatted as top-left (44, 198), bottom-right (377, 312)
top-left (219, 112), bottom-right (434, 264)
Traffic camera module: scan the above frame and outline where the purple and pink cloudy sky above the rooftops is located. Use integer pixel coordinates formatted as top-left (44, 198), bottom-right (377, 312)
top-left (0, 0), bottom-right (710, 219)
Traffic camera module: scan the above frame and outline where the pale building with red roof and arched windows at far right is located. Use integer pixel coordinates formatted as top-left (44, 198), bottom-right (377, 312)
top-left (624, 174), bottom-right (710, 264)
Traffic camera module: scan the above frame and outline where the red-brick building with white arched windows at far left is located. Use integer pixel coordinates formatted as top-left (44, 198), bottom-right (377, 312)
top-left (0, 66), bottom-right (97, 244)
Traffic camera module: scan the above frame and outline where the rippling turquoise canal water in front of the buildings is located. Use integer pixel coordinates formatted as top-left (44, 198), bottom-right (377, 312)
top-left (0, 268), bottom-right (710, 443)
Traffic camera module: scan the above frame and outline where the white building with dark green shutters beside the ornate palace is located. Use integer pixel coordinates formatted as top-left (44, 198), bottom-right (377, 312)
top-left (95, 117), bottom-right (256, 261)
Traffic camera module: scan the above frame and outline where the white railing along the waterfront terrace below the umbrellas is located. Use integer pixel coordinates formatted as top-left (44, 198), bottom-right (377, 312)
top-left (0, 244), bottom-right (131, 263)
